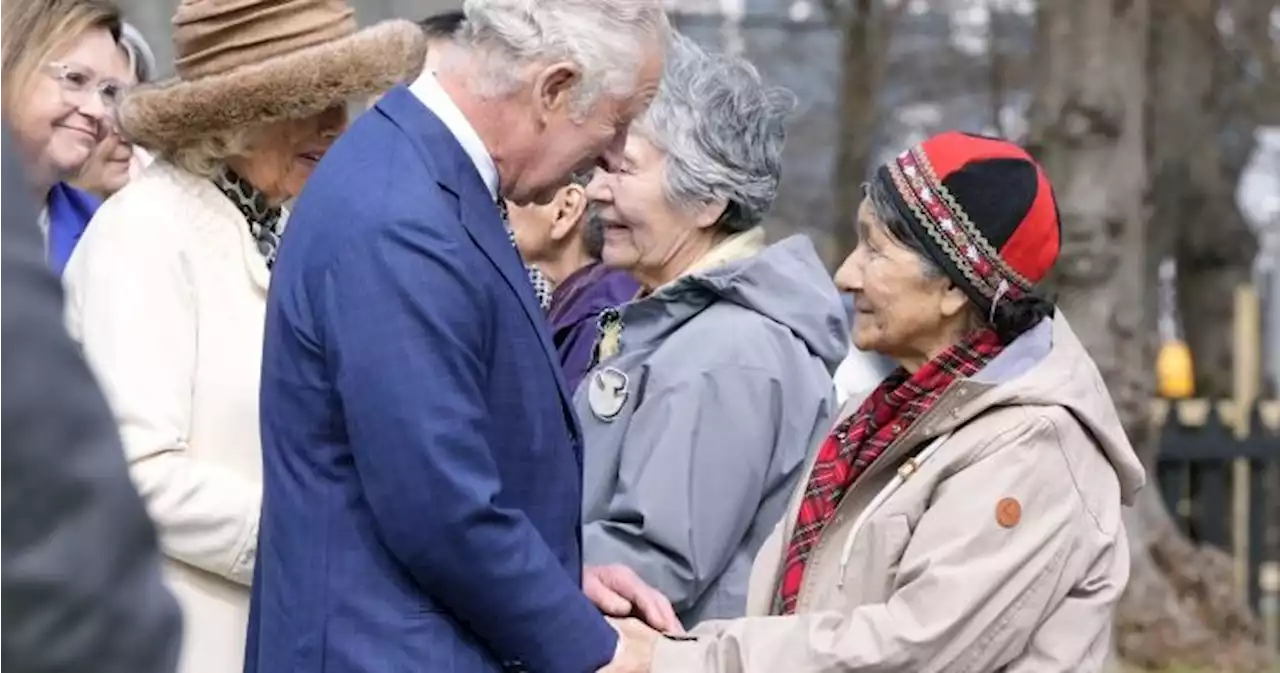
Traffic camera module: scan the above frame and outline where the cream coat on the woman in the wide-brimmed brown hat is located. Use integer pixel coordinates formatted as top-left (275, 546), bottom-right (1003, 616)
top-left (64, 162), bottom-right (269, 673)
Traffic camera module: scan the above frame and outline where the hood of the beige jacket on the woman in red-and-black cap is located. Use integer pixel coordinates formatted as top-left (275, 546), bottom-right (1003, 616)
top-left (960, 311), bottom-right (1146, 504)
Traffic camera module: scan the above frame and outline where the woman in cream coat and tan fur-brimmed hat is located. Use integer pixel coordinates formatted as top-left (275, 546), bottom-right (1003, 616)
top-left (65, 0), bottom-right (425, 673)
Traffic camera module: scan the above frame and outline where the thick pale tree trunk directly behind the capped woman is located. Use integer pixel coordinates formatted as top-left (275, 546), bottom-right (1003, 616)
top-left (1028, 0), bottom-right (1155, 465)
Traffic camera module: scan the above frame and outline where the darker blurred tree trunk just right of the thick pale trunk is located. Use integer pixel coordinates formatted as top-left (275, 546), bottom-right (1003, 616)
top-left (1148, 0), bottom-right (1268, 398)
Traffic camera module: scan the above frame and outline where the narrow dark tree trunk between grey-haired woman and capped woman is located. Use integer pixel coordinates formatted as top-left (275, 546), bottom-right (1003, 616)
top-left (827, 0), bottom-right (895, 267)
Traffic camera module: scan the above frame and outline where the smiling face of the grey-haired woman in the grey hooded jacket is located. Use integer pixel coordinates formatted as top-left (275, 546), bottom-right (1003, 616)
top-left (586, 134), bottom-right (713, 278)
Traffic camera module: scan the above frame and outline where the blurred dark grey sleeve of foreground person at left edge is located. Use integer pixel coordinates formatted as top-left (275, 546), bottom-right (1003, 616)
top-left (0, 127), bottom-right (182, 673)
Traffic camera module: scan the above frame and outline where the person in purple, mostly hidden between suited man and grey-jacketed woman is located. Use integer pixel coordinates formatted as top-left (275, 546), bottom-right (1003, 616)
top-left (509, 166), bottom-right (640, 390)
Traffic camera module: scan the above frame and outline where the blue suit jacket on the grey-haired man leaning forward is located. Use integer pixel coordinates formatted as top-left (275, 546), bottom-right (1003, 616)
top-left (246, 87), bottom-right (617, 673)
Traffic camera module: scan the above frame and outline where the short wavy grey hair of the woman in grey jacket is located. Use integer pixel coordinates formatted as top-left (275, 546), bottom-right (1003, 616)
top-left (634, 35), bottom-right (795, 232)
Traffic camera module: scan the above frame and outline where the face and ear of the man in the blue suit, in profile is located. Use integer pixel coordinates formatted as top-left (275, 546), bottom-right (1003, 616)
top-left (503, 44), bottom-right (662, 203)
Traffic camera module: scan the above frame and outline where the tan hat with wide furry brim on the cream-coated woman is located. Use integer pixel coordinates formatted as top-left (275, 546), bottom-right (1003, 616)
top-left (118, 0), bottom-right (426, 148)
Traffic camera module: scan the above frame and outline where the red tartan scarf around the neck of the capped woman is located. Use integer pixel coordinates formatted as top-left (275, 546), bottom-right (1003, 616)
top-left (773, 329), bottom-right (1004, 614)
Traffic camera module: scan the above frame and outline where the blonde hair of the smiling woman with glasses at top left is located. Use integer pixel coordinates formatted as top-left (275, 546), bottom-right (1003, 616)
top-left (0, 0), bottom-right (120, 118)
